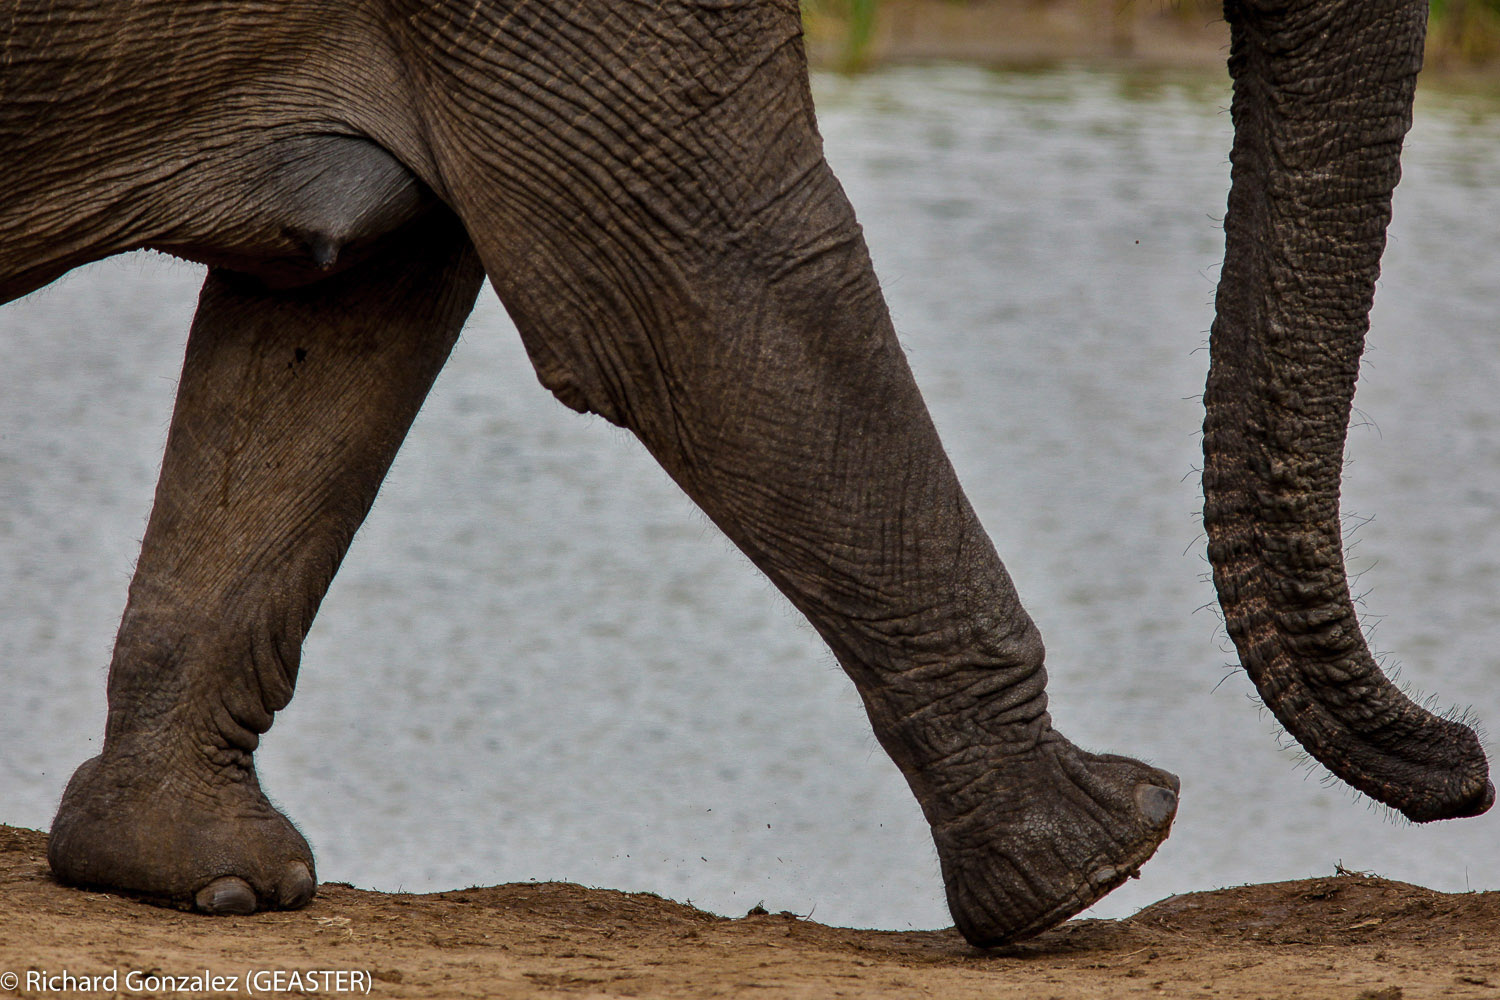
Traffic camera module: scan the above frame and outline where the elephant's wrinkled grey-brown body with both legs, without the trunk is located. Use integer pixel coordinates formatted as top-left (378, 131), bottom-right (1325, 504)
top-left (0, 0), bottom-right (1178, 945)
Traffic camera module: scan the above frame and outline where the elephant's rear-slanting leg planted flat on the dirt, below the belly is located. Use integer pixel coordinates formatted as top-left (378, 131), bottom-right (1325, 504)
top-left (48, 213), bottom-right (482, 913)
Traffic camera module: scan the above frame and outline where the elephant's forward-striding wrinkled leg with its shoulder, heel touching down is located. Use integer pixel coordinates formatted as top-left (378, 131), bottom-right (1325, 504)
top-left (407, 0), bottom-right (1178, 945)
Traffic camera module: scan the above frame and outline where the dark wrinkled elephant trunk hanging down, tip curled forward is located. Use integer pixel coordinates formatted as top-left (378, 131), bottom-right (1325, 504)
top-left (1203, 0), bottom-right (1494, 822)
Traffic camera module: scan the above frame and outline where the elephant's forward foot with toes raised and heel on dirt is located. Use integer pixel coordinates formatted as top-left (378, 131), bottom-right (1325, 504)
top-left (929, 730), bottom-right (1179, 948)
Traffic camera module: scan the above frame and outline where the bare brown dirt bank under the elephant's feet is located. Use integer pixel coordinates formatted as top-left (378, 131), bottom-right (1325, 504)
top-left (0, 826), bottom-right (1500, 1000)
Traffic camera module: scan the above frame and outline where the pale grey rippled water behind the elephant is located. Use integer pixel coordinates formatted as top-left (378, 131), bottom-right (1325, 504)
top-left (0, 69), bottom-right (1500, 928)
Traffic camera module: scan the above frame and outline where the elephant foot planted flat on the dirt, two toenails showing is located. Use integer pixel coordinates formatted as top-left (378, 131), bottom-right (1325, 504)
top-left (47, 750), bottom-right (318, 915)
